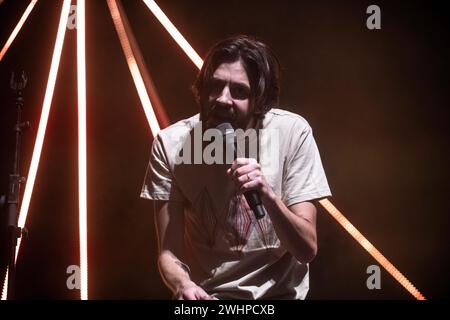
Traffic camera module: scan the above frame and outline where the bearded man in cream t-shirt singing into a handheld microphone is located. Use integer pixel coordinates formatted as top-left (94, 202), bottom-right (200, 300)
top-left (141, 36), bottom-right (331, 299)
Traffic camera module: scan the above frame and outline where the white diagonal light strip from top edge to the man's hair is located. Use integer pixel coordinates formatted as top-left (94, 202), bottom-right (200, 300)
top-left (144, 0), bottom-right (203, 69)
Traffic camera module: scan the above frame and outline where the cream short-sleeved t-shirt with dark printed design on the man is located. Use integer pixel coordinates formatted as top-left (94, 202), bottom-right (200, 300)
top-left (141, 109), bottom-right (331, 299)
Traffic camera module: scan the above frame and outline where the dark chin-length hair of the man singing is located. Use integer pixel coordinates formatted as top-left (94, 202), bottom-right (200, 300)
top-left (192, 35), bottom-right (280, 117)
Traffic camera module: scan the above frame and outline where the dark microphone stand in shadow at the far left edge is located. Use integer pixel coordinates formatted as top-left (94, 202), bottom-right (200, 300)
top-left (2, 71), bottom-right (30, 300)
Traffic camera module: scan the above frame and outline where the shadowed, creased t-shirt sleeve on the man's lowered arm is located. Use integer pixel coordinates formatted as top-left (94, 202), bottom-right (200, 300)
top-left (141, 135), bottom-right (184, 202)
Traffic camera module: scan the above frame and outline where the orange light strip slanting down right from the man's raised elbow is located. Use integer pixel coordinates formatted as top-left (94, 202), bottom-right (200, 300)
top-left (319, 199), bottom-right (426, 300)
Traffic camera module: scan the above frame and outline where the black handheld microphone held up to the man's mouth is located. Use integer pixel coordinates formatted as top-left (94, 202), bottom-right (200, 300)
top-left (216, 122), bottom-right (266, 219)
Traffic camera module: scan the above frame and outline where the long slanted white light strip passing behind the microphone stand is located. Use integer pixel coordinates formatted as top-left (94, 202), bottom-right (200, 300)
top-left (2, 0), bottom-right (71, 300)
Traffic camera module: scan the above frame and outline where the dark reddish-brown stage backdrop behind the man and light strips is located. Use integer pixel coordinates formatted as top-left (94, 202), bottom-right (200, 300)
top-left (0, 0), bottom-right (450, 299)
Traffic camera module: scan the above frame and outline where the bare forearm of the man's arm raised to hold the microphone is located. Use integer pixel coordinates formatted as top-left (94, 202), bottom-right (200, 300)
top-left (262, 196), bottom-right (317, 263)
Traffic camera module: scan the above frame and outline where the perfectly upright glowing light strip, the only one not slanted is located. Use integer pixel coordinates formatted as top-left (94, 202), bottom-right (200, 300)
top-left (77, 0), bottom-right (88, 300)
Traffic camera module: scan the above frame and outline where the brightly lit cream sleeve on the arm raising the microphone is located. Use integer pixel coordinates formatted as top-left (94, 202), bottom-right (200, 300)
top-left (282, 121), bottom-right (331, 206)
